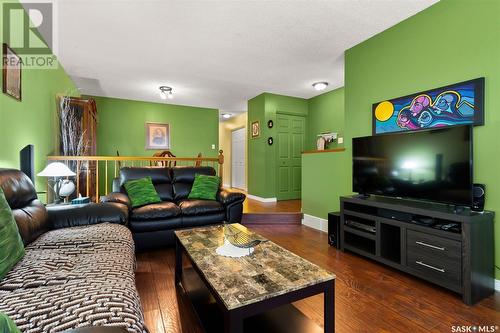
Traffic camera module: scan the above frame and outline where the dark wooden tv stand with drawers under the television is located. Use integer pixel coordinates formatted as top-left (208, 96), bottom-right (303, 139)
top-left (340, 195), bottom-right (495, 305)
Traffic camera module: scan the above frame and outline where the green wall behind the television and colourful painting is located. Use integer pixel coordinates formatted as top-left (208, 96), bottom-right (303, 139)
top-left (344, 0), bottom-right (500, 278)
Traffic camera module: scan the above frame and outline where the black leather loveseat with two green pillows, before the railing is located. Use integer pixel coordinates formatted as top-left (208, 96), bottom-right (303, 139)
top-left (101, 166), bottom-right (246, 250)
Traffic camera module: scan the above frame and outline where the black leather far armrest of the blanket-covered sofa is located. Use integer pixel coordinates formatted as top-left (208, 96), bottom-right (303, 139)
top-left (47, 202), bottom-right (128, 229)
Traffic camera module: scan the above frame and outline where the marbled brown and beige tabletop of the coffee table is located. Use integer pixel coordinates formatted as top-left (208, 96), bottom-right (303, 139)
top-left (175, 224), bottom-right (335, 310)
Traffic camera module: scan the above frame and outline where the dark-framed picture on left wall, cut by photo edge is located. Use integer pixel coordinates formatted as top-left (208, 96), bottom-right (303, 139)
top-left (2, 43), bottom-right (22, 101)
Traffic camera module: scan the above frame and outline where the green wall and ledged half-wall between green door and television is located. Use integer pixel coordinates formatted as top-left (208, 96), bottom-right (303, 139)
top-left (302, 88), bottom-right (350, 219)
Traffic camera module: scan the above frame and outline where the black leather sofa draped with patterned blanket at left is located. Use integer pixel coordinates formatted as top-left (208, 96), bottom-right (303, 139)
top-left (0, 169), bottom-right (147, 333)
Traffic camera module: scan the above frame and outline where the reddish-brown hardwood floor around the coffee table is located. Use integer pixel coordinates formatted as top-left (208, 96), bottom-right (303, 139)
top-left (136, 225), bottom-right (500, 333)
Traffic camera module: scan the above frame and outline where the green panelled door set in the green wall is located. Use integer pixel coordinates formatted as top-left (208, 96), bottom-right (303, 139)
top-left (276, 113), bottom-right (306, 200)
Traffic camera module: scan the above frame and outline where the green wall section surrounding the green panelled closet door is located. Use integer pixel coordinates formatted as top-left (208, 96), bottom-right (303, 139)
top-left (247, 93), bottom-right (308, 198)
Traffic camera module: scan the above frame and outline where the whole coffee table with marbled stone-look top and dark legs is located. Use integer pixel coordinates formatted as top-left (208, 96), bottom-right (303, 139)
top-left (175, 224), bottom-right (335, 333)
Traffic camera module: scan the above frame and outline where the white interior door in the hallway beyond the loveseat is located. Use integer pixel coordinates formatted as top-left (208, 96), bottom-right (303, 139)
top-left (231, 128), bottom-right (247, 189)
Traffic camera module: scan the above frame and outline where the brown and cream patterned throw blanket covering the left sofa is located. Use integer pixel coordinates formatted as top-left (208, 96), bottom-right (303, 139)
top-left (0, 223), bottom-right (147, 333)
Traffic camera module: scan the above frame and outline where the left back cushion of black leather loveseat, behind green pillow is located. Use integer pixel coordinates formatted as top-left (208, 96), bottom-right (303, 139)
top-left (119, 167), bottom-right (174, 201)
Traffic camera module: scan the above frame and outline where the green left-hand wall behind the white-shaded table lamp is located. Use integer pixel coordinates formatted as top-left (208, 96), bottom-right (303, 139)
top-left (0, 0), bottom-right (77, 195)
